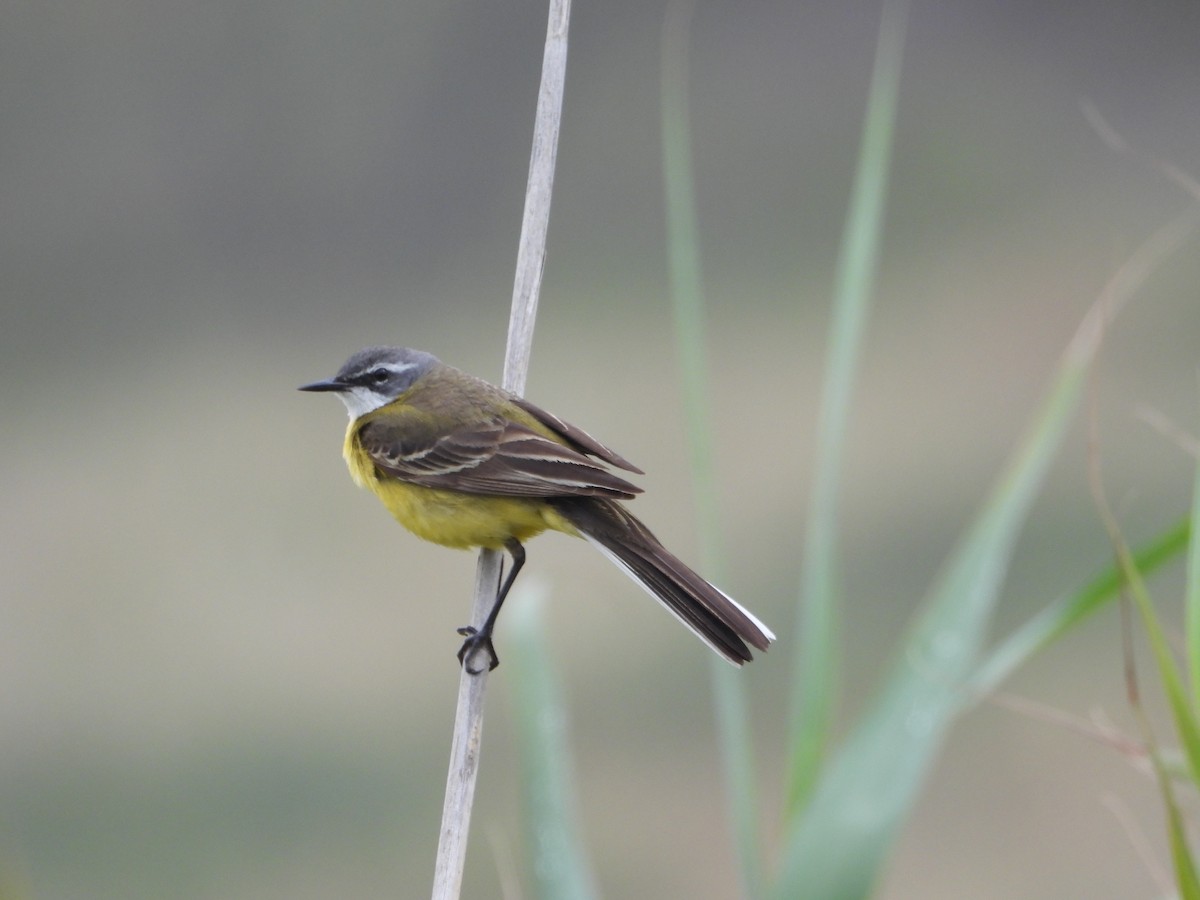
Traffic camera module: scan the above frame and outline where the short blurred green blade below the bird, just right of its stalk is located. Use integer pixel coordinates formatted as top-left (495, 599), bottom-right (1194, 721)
top-left (504, 583), bottom-right (599, 900)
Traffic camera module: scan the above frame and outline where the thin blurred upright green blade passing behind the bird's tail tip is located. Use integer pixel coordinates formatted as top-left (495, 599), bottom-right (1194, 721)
top-left (661, 0), bottom-right (763, 896)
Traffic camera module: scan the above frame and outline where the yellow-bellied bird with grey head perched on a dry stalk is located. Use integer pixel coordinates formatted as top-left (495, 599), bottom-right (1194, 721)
top-left (300, 347), bottom-right (775, 676)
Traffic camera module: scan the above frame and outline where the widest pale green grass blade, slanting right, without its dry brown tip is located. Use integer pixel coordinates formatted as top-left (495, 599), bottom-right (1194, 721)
top-left (778, 283), bottom-right (1100, 900)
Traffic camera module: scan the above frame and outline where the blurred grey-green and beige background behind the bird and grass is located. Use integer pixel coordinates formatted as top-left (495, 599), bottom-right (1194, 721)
top-left (0, 0), bottom-right (1200, 900)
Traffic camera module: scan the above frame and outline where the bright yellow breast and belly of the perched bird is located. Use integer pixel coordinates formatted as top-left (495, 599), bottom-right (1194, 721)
top-left (344, 424), bottom-right (577, 550)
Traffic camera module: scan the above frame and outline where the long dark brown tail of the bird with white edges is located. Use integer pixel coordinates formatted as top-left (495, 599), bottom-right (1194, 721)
top-left (552, 497), bottom-right (775, 666)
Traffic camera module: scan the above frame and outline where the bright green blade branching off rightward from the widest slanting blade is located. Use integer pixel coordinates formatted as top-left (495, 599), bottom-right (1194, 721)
top-left (964, 518), bottom-right (1195, 700)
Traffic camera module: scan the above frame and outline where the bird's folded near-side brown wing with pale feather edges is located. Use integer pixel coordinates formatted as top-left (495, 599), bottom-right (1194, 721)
top-left (359, 416), bottom-right (642, 499)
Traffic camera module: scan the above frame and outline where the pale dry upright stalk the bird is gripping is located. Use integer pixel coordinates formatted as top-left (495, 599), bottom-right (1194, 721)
top-left (432, 0), bottom-right (571, 900)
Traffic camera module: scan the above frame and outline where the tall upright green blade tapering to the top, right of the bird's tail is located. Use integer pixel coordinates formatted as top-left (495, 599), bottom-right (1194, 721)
top-left (787, 0), bottom-right (908, 816)
